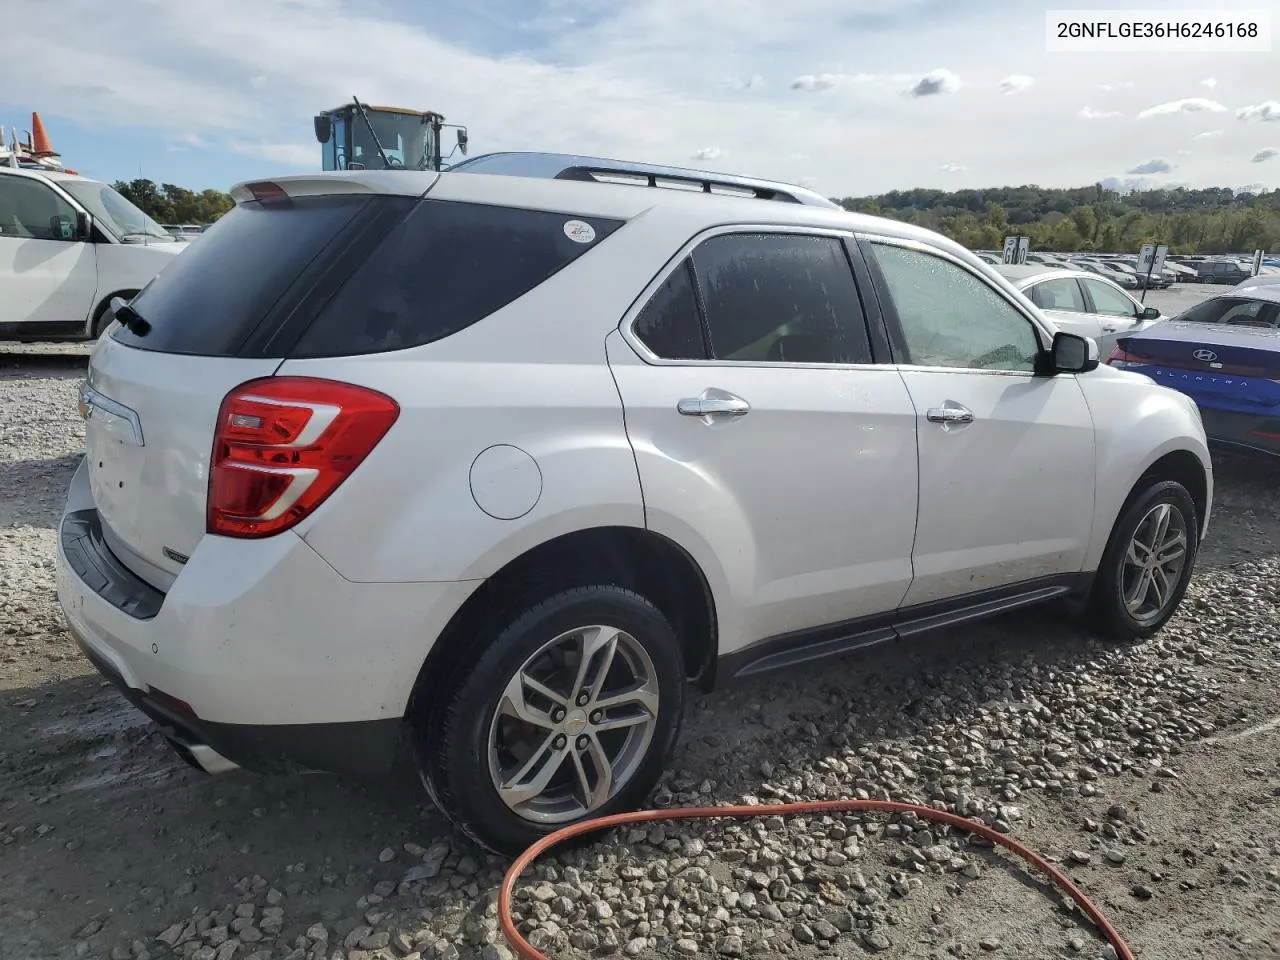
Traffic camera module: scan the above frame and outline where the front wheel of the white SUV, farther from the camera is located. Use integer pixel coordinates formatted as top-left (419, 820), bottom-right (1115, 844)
top-left (1087, 480), bottom-right (1199, 643)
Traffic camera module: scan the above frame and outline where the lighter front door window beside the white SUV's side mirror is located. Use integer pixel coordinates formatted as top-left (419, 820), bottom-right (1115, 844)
top-left (869, 243), bottom-right (1041, 372)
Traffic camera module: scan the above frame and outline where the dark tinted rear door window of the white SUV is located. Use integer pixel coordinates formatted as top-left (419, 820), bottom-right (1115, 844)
top-left (694, 233), bottom-right (872, 364)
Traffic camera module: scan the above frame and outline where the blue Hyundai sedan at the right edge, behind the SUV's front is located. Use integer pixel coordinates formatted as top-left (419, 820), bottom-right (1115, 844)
top-left (1107, 283), bottom-right (1280, 457)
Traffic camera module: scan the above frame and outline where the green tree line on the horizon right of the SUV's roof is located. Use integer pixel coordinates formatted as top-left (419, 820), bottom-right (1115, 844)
top-left (836, 184), bottom-right (1280, 253)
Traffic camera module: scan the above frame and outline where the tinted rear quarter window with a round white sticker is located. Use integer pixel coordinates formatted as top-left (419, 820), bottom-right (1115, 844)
top-left (294, 200), bottom-right (622, 357)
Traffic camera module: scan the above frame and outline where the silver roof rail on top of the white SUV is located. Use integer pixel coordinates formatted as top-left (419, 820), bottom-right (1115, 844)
top-left (448, 151), bottom-right (838, 209)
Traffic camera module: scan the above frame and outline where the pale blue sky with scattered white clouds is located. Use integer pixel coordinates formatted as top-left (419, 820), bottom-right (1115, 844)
top-left (0, 0), bottom-right (1280, 197)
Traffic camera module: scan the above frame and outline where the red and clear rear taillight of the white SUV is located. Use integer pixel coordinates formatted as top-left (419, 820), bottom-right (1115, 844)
top-left (206, 376), bottom-right (399, 538)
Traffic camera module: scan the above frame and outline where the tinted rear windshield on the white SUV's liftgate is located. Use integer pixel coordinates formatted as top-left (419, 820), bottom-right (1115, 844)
top-left (111, 195), bottom-right (370, 357)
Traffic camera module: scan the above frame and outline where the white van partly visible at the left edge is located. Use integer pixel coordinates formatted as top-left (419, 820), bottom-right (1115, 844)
top-left (0, 168), bottom-right (187, 340)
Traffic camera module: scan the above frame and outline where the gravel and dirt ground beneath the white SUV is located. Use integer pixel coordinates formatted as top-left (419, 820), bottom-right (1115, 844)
top-left (0, 320), bottom-right (1280, 960)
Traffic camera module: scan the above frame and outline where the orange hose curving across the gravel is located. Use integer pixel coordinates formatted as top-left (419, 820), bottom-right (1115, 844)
top-left (498, 800), bottom-right (1135, 960)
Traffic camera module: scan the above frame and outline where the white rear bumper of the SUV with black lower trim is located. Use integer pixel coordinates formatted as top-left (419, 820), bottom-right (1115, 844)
top-left (56, 462), bottom-right (475, 773)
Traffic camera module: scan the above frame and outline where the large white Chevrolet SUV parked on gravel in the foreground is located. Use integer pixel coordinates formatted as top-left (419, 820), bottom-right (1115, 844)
top-left (58, 155), bottom-right (1212, 851)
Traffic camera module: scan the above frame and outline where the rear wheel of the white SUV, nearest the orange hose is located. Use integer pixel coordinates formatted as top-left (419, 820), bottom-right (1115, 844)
top-left (415, 585), bottom-right (685, 855)
